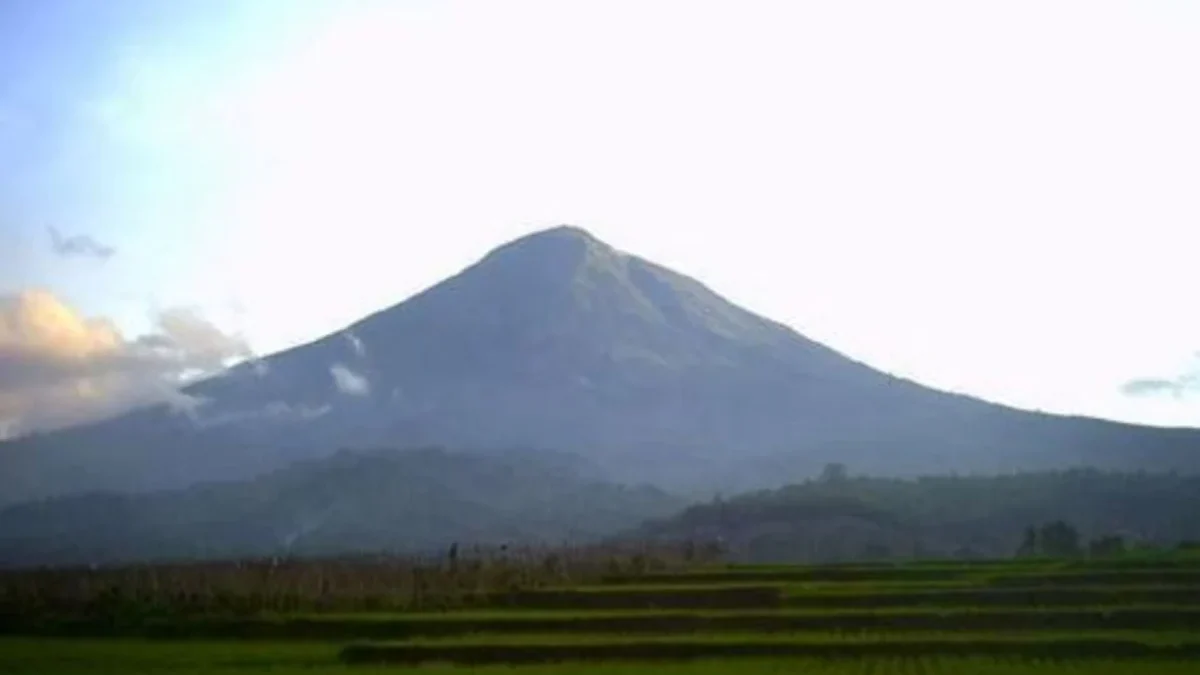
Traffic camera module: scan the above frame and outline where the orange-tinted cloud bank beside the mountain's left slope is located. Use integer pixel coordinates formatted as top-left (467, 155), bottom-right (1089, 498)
top-left (0, 289), bottom-right (253, 436)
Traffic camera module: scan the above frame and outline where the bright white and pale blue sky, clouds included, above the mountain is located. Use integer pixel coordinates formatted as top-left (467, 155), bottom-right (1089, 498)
top-left (0, 0), bottom-right (1200, 435)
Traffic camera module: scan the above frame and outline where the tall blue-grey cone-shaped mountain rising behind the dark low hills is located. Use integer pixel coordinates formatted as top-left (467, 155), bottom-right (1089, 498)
top-left (0, 227), bottom-right (1200, 502)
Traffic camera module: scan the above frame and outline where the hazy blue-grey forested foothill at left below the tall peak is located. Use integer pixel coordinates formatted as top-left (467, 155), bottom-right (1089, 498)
top-left (0, 449), bottom-right (683, 565)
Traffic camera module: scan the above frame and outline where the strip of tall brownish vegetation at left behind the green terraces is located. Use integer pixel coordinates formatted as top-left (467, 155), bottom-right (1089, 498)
top-left (0, 544), bottom-right (706, 617)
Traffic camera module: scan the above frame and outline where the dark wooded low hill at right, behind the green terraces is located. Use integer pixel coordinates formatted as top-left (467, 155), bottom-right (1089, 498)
top-left (634, 470), bottom-right (1200, 562)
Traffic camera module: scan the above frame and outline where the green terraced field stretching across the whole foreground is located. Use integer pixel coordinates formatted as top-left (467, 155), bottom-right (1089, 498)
top-left (0, 556), bottom-right (1200, 675)
